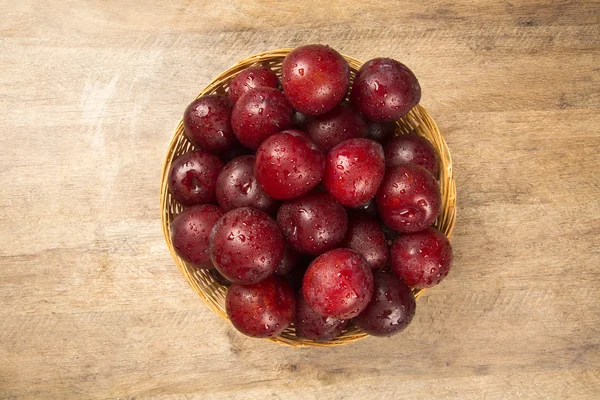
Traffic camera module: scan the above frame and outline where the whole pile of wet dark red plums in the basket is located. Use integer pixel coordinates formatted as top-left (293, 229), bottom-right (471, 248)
top-left (168, 45), bottom-right (452, 341)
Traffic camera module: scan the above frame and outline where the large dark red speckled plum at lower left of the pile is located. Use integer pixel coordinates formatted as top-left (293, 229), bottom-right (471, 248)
top-left (210, 208), bottom-right (284, 284)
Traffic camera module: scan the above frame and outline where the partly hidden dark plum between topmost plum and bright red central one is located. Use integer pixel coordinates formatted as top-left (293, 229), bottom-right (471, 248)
top-left (304, 102), bottom-right (369, 151)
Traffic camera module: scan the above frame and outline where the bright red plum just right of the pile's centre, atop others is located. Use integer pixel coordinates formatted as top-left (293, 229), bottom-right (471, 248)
top-left (323, 139), bottom-right (385, 207)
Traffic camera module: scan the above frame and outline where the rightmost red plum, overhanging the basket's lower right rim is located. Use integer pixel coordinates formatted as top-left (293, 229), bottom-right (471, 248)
top-left (390, 228), bottom-right (452, 289)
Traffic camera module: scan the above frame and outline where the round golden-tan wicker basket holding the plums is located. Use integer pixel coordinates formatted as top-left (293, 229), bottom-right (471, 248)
top-left (160, 49), bottom-right (456, 347)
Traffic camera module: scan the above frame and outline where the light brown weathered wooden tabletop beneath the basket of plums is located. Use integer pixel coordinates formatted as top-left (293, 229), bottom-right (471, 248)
top-left (0, 0), bottom-right (600, 399)
